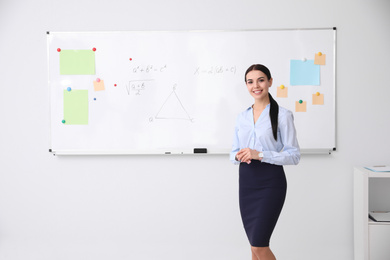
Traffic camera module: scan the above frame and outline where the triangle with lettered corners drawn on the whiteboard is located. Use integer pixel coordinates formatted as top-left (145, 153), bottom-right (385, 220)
top-left (155, 88), bottom-right (193, 122)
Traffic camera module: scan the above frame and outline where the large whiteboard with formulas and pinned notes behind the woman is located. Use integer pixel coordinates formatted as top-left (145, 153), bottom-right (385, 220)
top-left (47, 28), bottom-right (336, 154)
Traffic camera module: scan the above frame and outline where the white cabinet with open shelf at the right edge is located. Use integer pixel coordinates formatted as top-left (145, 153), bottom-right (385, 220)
top-left (354, 167), bottom-right (390, 260)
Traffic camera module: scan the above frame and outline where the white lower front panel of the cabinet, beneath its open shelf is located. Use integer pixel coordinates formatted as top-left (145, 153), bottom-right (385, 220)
top-left (369, 225), bottom-right (390, 260)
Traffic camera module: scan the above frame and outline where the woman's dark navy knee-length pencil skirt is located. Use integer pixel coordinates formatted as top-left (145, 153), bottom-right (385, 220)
top-left (239, 160), bottom-right (287, 247)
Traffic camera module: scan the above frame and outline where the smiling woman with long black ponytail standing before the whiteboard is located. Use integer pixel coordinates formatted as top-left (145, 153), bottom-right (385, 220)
top-left (230, 64), bottom-right (300, 260)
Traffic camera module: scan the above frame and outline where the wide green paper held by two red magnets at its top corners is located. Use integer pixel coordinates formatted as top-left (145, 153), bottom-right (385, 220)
top-left (60, 50), bottom-right (95, 75)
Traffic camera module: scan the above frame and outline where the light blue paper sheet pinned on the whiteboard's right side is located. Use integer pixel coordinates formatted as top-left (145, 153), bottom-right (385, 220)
top-left (290, 60), bottom-right (320, 86)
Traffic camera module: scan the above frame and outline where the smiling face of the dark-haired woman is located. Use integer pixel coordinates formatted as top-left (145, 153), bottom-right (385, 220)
top-left (246, 70), bottom-right (272, 99)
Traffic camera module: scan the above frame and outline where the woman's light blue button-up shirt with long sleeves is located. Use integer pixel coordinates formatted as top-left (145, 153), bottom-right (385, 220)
top-left (230, 104), bottom-right (301, 165)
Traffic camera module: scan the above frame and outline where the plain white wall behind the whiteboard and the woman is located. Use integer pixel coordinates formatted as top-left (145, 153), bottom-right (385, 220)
top-left (0, 0), bottom-right (390, 260)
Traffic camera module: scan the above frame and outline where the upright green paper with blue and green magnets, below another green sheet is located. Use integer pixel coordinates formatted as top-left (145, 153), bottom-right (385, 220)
top-left (63, 90), bottom-right (88, 125)
